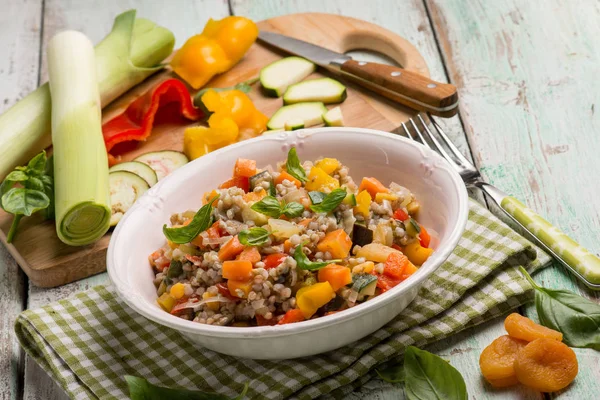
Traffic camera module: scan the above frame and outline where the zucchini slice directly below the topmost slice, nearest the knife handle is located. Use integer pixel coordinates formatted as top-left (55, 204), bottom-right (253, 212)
top-left (283, 78), bottom-right (347, 104)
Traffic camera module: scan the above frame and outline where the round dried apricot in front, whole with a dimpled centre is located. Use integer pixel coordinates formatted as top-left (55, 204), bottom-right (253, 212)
top-left (515, 338), bottom-right (578, 392)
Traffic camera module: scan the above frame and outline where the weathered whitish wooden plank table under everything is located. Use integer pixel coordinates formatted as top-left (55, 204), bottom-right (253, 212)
top-left (0, 0), bottom-right (600, 400)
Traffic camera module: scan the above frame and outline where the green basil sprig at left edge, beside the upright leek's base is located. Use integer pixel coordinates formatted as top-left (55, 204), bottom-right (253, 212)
top-left (0, 151), bottom-right (54, 243)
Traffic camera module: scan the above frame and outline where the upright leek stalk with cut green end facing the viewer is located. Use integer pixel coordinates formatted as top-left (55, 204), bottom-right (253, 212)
top-left (48, 31), bottom-right (111, 246)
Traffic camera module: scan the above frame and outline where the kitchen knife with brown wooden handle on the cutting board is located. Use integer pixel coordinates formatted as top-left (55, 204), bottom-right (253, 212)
top-left (258, 31), bottom-right (458, 117)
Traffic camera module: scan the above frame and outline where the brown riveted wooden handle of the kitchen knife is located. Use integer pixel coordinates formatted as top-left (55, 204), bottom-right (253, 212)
top-left (341, 60), bottom-right (458, 118)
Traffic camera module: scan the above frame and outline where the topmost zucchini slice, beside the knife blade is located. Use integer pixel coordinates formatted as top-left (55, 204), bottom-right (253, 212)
top-left (260, 57), bottom-right (316, 97)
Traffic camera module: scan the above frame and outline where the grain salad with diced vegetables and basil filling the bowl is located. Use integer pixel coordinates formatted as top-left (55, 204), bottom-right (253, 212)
top-left (149, 148), bottom-right (433, 327)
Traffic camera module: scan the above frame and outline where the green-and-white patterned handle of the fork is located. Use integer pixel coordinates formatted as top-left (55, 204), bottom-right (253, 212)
top-left (500, 196), bottom-right (600, 286)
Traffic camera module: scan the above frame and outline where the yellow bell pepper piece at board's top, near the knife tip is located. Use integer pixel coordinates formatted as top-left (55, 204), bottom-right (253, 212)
top-left (171, 16), bottom-right (258, 89)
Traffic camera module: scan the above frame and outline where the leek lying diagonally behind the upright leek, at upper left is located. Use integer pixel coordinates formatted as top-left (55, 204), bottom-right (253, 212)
top-left (0, 10), bottom-right (175, 179)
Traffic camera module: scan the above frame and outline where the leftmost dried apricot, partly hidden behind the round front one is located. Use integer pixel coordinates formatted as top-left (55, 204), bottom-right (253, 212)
top-left (479, 335), bottom-right (527, 386)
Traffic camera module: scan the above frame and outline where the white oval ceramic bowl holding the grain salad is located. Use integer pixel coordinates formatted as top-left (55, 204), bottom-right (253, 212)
top-left (107, 128), bottom-right (468, 359)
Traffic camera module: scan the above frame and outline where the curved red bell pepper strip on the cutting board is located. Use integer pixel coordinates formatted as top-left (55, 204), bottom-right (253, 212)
top-left (102, 78), bottom-right (204, 165)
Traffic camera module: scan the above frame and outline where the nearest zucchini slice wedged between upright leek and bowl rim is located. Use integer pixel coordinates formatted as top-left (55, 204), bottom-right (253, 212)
top-left (108, 171), bottom-right (150, 226)
